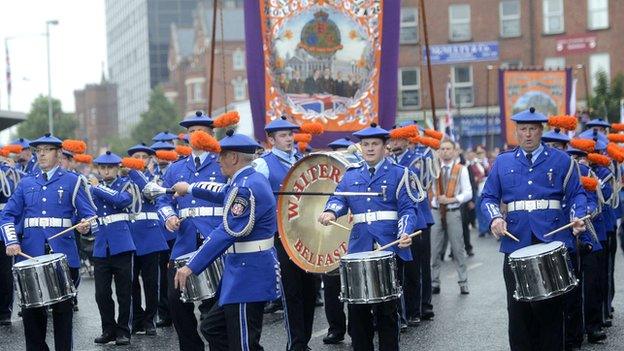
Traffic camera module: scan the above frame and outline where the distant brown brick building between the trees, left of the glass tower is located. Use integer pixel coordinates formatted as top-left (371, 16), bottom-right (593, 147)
top-left (74, 77), bottom-right (118, 155)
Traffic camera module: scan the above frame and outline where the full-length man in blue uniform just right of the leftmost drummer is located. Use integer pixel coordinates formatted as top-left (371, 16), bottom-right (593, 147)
top-left (91, 151), bottom-right (136, 345)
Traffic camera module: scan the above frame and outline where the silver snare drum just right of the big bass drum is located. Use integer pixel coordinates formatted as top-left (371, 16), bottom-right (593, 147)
top-left (340, 251), bottom-right (402, 304)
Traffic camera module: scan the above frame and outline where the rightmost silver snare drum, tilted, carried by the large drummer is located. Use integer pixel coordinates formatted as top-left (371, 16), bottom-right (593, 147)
top-left (509, 241), bottom-right (578, 302)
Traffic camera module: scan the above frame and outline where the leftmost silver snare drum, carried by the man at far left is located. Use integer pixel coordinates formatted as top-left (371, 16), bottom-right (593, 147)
top-left (13, 253), bottom-right (76, 308)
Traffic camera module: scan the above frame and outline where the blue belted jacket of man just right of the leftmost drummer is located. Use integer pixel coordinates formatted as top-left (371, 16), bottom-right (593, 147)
top-left (91, 177), bottom-right (136, 257)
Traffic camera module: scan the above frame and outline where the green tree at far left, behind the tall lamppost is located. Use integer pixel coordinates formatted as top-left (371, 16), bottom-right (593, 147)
top-left (17, 95), bottom-right (76, 139)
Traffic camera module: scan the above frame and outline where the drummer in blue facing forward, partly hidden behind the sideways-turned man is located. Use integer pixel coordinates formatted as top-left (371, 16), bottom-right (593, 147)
top-left (157, 111), bottom-right (225, 351)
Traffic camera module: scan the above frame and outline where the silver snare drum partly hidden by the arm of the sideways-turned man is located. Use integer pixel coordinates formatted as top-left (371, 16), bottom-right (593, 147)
top-left (175, 252), bottom-right (223, 302)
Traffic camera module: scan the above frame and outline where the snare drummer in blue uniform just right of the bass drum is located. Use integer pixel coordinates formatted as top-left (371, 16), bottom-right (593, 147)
top-left (318, 123), bottom-right (416, 350)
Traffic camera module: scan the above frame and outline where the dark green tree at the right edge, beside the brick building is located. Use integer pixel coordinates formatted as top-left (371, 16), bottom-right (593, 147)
top-left (591, 71), bottom-right (624, 123)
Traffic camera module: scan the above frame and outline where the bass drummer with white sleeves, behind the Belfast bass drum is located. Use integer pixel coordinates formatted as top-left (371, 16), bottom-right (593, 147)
top-left (254, 117), bottom-right (320, 351)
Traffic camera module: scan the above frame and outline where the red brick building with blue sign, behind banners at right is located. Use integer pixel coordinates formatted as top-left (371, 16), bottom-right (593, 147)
top-left (397, 0), bottom-right (624, 147)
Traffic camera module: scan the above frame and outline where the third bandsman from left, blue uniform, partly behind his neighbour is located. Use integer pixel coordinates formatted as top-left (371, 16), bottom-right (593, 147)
top-left (128, 144), bottom-right (169, 335)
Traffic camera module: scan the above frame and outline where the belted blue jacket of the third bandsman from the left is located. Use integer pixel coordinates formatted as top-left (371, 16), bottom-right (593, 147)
top-left (128, 169), bottom-right (169, 256)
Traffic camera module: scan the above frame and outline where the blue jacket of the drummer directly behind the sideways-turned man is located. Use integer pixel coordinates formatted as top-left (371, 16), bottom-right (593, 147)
top-left (157, 153), bottom-right (226, 259)
